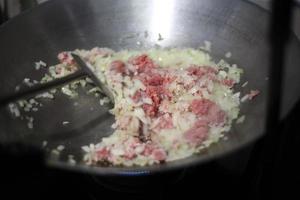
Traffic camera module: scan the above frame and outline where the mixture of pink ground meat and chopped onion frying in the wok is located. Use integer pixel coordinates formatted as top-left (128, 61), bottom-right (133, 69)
top-left (10, 48), bottom-right (258, 166)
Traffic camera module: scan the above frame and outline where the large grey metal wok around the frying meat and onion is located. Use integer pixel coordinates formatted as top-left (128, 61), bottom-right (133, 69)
top-left (0, 0), bottom-right (299, 175)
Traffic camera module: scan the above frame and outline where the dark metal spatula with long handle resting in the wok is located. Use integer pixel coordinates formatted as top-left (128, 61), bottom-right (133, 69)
top-left (0, 53), bottom-right (114, 106)
